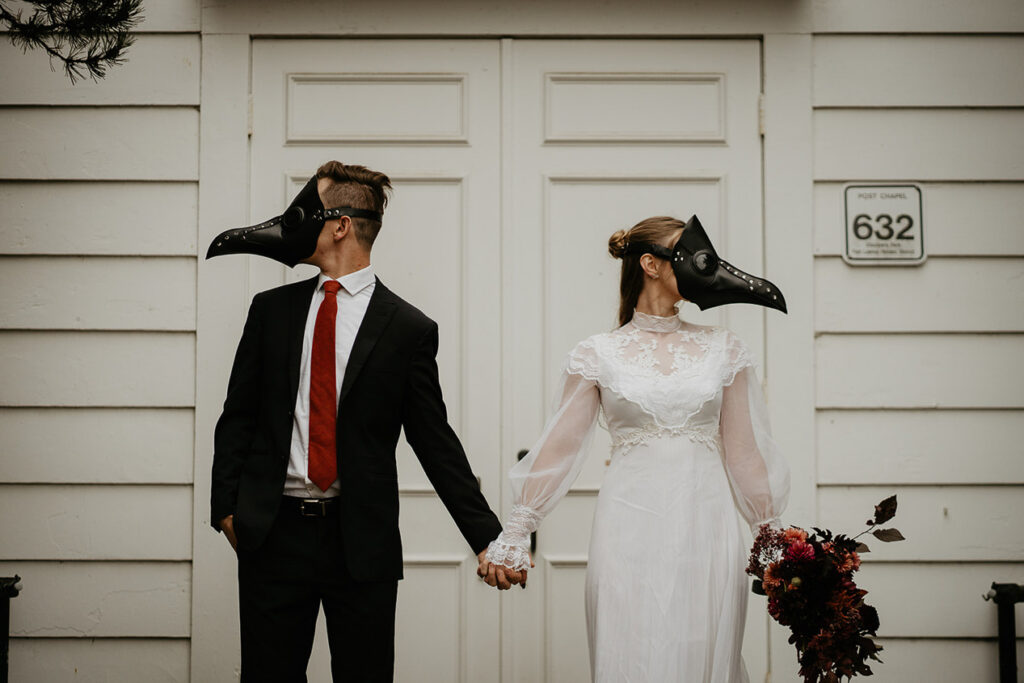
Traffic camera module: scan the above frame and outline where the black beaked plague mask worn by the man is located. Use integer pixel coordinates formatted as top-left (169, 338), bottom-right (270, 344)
top-left (206, 176), bottom-right (384, 267)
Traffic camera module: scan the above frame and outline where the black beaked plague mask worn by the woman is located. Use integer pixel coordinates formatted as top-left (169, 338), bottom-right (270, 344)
top-left (625, 216), bottom-right (786, 313)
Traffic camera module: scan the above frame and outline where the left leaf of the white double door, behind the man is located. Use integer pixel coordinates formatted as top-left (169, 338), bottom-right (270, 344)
top-left (249, 40), bottom-right (504, 682)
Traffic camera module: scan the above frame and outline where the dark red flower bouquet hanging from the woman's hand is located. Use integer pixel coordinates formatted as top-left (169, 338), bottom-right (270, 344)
top-left (746, 496), bottom-right (903, 683)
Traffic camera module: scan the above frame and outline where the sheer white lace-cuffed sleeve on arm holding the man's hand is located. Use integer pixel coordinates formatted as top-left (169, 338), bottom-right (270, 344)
top-left (487, 342), bottom-right (601, 570)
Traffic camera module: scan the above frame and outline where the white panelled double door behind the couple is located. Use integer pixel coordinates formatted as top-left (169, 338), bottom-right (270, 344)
top-left (250, 39), bottom-right (766, 683)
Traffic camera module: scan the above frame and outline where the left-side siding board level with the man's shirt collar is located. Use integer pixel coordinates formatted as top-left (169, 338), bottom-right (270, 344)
top-left (0, 256), bottom-right (196, 330)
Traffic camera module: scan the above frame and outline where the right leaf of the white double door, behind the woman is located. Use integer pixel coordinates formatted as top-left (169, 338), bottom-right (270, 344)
top-left (504, 40), bottom-right (765, 683)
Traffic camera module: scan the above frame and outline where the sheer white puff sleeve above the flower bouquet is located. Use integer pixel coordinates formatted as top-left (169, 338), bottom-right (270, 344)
top-left (720, 333), bottom-right (790, 533)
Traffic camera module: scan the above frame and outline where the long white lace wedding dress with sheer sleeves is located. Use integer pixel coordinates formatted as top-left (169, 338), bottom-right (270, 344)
top-left (488, 312), bottom-right (788, 683)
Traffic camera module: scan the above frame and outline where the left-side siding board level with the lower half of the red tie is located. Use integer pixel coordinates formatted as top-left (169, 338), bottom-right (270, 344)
top-left (0, 408), bottom-right (195, 483)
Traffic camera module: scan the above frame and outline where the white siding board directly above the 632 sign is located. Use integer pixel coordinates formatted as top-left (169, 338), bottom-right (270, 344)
top-left (814, 109), bottom-right (1024, 180)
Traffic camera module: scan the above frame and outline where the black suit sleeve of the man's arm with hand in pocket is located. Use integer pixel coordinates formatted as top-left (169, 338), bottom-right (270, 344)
top-left (210, 295), bottom-right (262, 531)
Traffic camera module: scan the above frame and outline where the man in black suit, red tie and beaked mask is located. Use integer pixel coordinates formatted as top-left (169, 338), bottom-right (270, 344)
top-left (208, 162), bottom-right (520, 683)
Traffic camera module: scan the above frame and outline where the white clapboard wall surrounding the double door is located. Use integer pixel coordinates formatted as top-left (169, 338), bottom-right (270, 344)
top-left (0, 0), bottom-right (1024, 681)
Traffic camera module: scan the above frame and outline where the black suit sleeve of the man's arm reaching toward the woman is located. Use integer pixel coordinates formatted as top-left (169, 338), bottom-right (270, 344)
top-left (402, 323), bottom-right (502, 553)
